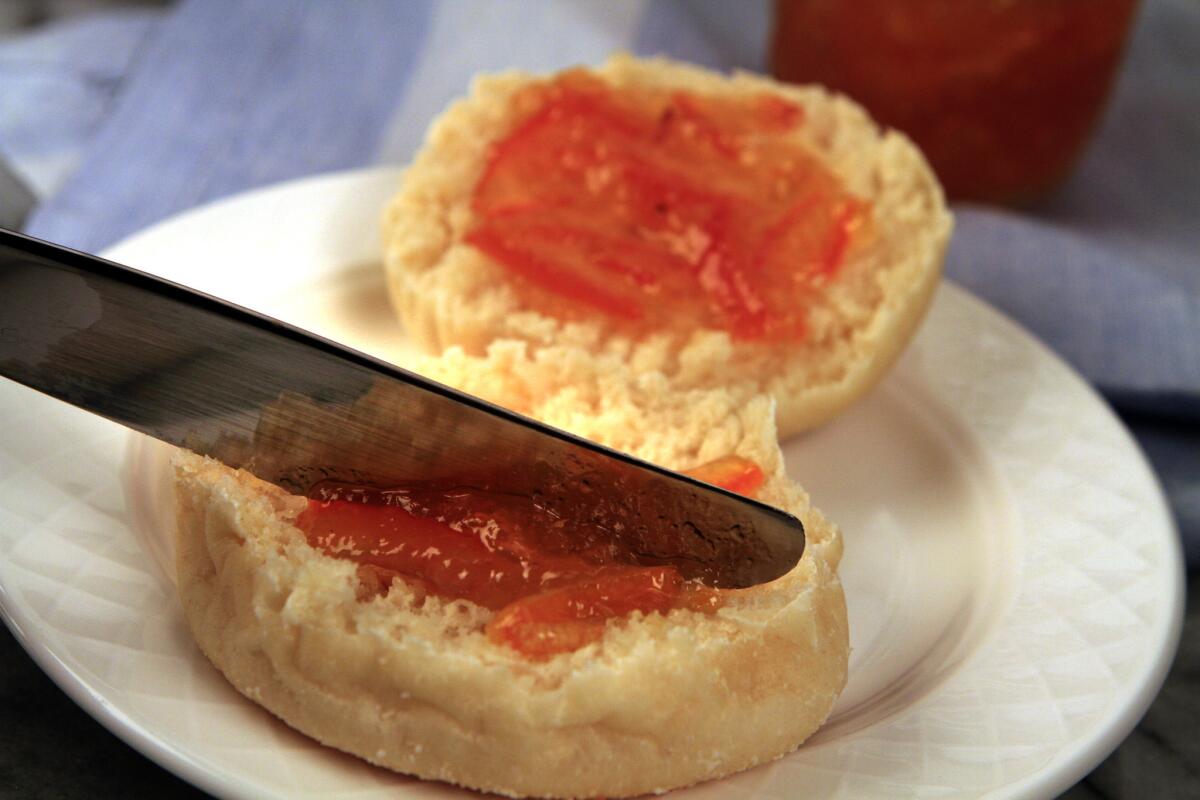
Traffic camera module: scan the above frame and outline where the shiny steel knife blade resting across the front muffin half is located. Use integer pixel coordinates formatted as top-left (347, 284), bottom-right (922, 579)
top-left (0, 230), bottom-right (804, 588)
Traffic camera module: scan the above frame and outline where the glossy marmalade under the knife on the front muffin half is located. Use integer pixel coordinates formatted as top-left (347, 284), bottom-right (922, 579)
top-left (296, 456), bottom-right (763, 658)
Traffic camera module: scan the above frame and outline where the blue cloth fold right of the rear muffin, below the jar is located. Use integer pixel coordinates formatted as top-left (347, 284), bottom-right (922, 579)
top-left (947, 209), bottom-right (1200, 412)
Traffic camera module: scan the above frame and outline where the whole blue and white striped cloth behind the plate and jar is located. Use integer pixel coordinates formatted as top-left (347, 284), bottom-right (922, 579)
top-left (0, 0), bottom-right (1200, 560)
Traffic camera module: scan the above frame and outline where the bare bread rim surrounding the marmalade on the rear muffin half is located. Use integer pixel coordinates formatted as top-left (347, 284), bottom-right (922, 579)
top-left (384, 56), bottom-right (952, 437)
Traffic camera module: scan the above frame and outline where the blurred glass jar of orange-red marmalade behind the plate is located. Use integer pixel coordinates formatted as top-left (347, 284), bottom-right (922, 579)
top-left (770, 0), bottom-right (1138, 204)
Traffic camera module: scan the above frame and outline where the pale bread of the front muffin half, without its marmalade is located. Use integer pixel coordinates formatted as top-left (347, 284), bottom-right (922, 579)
top-left (175, 342), bottom-right (848, 796)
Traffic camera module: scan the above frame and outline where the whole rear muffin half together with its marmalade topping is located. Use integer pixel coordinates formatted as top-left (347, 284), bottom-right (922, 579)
top-left (385, 56), bottom-right (952, 437)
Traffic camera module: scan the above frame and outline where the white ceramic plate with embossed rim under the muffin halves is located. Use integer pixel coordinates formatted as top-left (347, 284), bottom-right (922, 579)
top-left (0, 172), bottom-right (1182, 798)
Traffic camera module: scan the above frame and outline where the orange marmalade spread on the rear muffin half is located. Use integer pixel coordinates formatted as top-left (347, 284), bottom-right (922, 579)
top-left (466, 71), bottom-right (869, 341)
